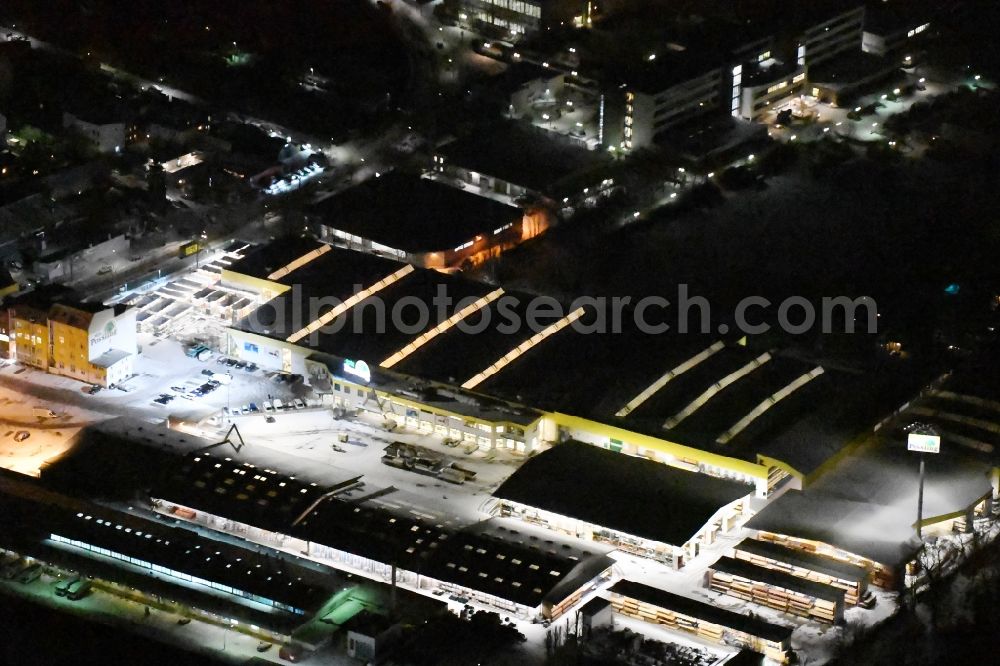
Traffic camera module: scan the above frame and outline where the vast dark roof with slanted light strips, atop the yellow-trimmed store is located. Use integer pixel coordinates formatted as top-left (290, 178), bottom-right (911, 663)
top-left (225, 245), bottom-right (928, 475)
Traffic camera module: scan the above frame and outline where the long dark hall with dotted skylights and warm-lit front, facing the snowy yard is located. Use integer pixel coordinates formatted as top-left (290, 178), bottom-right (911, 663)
top-left (145, 452), bottom-right (611, 617)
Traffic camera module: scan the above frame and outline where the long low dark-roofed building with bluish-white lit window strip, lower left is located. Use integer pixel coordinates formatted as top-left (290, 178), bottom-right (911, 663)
top-left (0, 479), bottom-right (333, 640)
